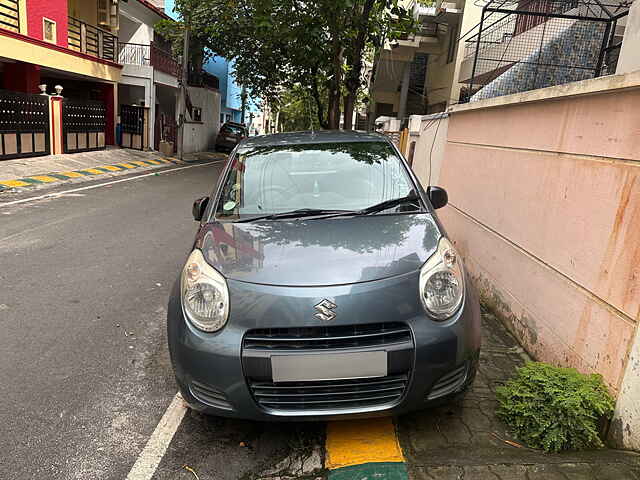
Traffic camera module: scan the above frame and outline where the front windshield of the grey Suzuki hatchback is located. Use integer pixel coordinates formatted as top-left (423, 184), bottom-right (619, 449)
top-left (216, 142), bottom-right (414, 218)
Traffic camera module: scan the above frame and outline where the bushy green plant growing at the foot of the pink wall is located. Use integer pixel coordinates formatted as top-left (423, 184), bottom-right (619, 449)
top-left (496, 362), bottom-right (614, 452)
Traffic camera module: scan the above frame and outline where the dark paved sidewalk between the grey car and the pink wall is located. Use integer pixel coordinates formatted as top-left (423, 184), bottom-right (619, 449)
top-left (398, 314), bottom-right (640, 480)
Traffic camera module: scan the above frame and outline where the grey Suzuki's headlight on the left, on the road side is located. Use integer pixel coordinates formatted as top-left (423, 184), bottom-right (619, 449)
top-left (180, 250), bottom-right (229, 332)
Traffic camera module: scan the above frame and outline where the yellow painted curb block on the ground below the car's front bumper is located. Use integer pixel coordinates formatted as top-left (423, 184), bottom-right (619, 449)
top-left (325, 417), bottom-right (404, 470)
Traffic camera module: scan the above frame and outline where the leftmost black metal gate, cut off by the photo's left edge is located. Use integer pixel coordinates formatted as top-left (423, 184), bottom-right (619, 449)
top-left (0, 90), bottom-right (51, 160)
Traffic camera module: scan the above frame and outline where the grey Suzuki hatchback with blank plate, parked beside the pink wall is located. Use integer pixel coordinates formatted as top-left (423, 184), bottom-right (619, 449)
top-left (167, 132), bottom-right (480, 420)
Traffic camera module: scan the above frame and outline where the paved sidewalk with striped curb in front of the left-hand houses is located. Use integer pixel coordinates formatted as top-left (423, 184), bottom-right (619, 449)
top-left (0, 148), bottom-right (226, 193)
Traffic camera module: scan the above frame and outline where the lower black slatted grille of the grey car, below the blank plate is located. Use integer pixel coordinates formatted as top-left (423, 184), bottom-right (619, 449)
top-left (249, 374), bottom-right (409, 411)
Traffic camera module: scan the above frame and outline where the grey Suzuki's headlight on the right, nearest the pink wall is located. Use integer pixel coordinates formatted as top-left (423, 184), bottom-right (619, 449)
top-left (420, 237), bottom-right (464, 320)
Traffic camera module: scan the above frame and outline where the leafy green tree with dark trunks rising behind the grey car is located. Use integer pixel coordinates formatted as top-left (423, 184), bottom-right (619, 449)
top-left (160, 0), bottom-right (413, 128)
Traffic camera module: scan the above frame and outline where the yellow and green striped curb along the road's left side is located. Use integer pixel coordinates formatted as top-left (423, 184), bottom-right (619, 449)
top-left (0, 158), bottom-right (185, 192)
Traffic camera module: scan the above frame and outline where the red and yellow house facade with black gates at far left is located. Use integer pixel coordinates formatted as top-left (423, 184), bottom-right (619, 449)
top-left (0, 0), bottom-right (122, 158)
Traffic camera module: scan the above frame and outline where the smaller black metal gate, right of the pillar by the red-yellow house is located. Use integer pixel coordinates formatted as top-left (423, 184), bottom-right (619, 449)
top-left (62, 98), bottom-right (107, 153)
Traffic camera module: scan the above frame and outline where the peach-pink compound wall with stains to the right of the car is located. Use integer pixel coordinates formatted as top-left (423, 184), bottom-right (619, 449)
top-left (438, 72), bottom-right (640, 448)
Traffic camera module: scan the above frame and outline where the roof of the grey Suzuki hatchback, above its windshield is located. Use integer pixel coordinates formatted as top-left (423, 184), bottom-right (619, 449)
top-left (240, 130), bottom-right (389, 148)
